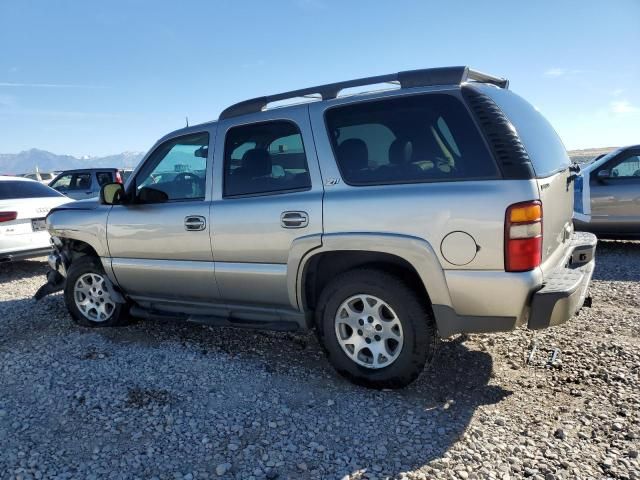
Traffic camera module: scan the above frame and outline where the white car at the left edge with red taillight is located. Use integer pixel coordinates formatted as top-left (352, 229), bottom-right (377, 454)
top-left (0, 176), bottom-right (70, 262)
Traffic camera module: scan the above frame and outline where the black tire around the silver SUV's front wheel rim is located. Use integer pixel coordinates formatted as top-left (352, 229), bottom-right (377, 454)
top-left (64, 256), bottom-right (129, 327)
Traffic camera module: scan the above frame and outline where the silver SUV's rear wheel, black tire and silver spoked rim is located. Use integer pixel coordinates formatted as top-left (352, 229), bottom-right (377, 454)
top-left (316, 269), bottom-right (437, 388)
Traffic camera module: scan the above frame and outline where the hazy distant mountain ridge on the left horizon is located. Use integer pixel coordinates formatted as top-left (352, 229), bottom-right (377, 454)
top-left (0, 148), bottom-right (144, 174)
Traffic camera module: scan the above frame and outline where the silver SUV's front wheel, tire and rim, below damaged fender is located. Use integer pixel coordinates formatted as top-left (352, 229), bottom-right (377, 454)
top-left (64, 256), bottom-right (129, 327)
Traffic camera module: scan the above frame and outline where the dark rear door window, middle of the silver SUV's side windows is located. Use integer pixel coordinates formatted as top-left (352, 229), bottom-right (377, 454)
top-left (224, 121), bottom-right (311, 196)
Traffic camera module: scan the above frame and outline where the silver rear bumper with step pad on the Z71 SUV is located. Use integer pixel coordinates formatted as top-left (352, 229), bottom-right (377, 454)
top-left (527, 232), bottom-right (597, 330)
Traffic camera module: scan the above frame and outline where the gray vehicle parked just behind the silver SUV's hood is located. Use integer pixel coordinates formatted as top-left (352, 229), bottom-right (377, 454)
top-left (49, 168), bottom-right (131, 200)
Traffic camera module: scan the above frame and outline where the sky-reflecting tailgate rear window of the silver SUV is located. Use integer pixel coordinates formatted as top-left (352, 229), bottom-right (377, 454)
top-left (482, 87), bottom-right (571, 178)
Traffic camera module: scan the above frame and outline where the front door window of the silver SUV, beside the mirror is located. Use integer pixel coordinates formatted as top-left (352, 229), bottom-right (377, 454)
top-left (135, 133), bottom-right (209, 201)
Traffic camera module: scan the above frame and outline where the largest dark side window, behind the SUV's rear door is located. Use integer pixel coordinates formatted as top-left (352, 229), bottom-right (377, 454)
top-left (326, 94), bottom-right (499, 185)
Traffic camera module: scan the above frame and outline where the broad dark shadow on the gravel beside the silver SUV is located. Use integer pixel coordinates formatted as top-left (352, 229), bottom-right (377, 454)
top-left (0, 296), bottom-right (511, 479)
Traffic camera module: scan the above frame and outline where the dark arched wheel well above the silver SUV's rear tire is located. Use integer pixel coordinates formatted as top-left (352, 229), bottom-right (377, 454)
top-left (302, 250), bottom-right (429, 311)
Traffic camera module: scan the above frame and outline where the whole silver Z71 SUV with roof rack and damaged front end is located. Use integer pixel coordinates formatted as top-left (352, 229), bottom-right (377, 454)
top-left (37, 67), bottom-right (596, 388)
